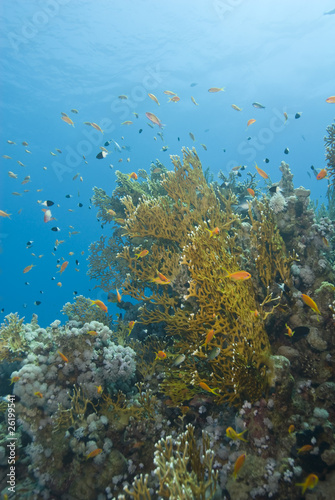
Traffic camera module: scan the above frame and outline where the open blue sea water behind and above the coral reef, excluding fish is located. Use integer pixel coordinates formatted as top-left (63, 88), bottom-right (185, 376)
top-left (0, 0), bottom-right (335, 326)
